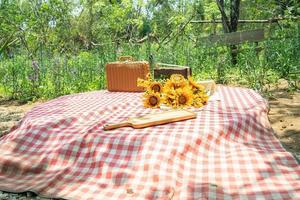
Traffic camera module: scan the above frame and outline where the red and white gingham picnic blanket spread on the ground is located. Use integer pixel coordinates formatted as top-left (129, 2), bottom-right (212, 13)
top-left (0, 86), bottom-right (300, 200)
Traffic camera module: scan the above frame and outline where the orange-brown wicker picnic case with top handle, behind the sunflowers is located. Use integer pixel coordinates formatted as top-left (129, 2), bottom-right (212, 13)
top-left (105, 56), bottom-right (150, 92)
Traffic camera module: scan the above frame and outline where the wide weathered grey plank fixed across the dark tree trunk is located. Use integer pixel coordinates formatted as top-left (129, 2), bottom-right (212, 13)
top-left (201, 29), bottom-right (265, 45)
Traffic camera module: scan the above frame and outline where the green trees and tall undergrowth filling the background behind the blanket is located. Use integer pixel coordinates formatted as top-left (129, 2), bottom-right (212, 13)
top-left (0, 0), bottom-right (300, 100)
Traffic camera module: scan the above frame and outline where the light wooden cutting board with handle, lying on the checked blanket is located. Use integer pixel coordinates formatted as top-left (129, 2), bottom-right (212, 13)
top-left (103, 110), bottom-right (197, 131)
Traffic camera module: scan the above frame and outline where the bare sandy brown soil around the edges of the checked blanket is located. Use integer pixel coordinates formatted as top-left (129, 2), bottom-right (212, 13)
top-left (0, 84), bottom-right (300, 200)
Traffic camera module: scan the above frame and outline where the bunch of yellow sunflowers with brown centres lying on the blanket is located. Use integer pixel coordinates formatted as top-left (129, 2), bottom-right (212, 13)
top-left (137, 74), bottom-right (208, 108)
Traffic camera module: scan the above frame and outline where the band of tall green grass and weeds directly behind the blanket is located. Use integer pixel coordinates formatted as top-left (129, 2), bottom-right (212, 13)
top-left (0, 33), bottom-right (300, 101)
